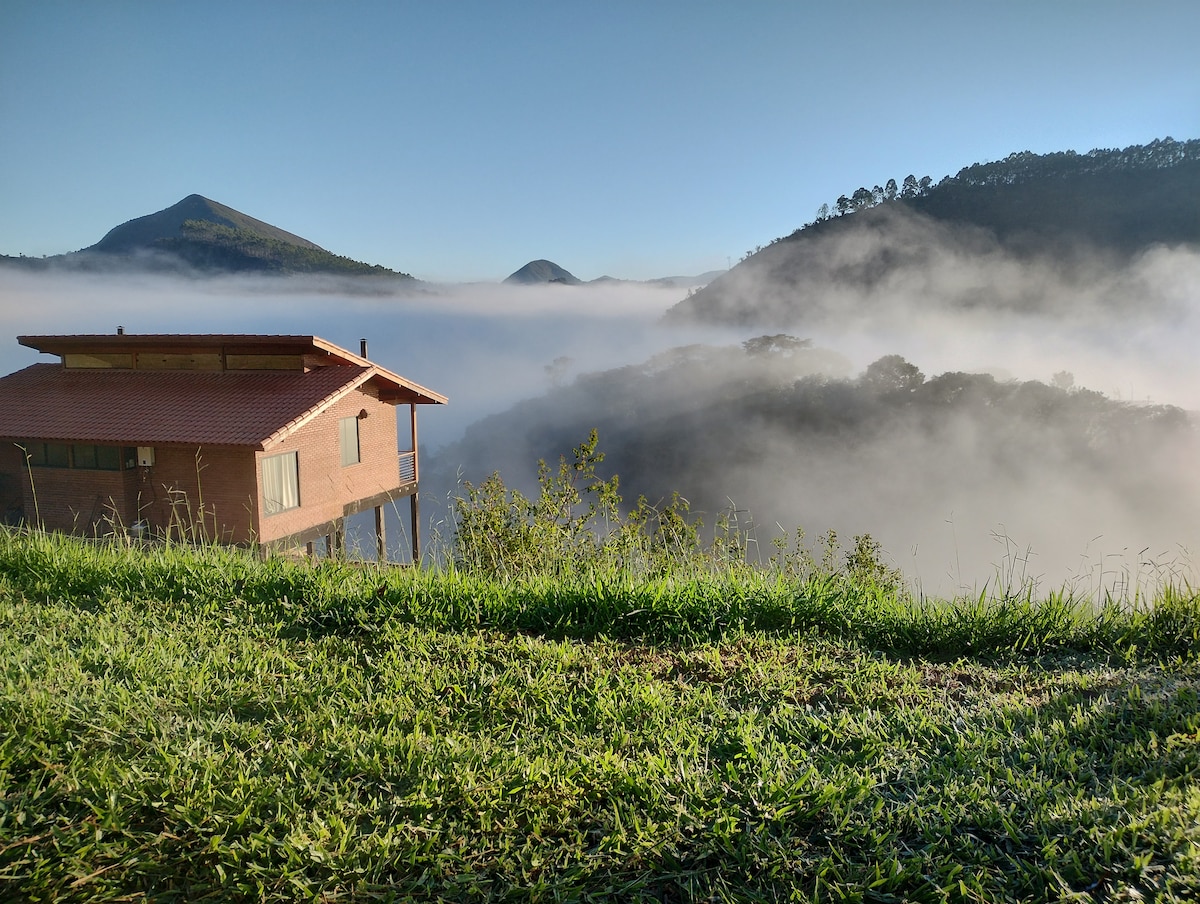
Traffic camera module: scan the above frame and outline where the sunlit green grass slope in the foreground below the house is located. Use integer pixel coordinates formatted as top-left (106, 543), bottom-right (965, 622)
top-left (0, 525), bottom-right (1200, 902)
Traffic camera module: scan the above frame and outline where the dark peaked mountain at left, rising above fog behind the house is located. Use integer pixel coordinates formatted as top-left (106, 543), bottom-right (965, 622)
top-left (4, 194), bottom-right (413, 280)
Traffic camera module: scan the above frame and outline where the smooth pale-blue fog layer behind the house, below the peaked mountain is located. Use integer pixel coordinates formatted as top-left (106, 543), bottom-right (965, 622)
top-left (0, 268), bottom-right (712, 449)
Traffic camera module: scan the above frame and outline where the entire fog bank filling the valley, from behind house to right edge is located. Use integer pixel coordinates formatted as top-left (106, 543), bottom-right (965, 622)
top-left (0, 224), bottom-right (1200, 593)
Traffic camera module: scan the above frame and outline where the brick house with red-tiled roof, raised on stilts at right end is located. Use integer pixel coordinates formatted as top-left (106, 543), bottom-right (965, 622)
top-left (0, 330), bottom-right (446, 561)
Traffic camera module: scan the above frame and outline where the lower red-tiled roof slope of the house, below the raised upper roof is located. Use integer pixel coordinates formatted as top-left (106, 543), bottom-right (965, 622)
top-left (0, 364), bottom-right (382, 449)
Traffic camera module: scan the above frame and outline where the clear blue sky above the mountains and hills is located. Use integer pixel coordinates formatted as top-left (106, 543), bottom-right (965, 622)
top-left (0, 0), bottom-right (1200, 281)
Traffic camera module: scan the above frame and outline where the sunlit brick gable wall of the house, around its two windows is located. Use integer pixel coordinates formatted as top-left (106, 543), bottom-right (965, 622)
top-left (256, 385), bottom-right (408, 543)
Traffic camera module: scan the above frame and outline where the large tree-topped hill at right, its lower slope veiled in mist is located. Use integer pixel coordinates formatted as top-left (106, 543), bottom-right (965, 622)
top-left (667, 138), bottom-right (1200, 328)
